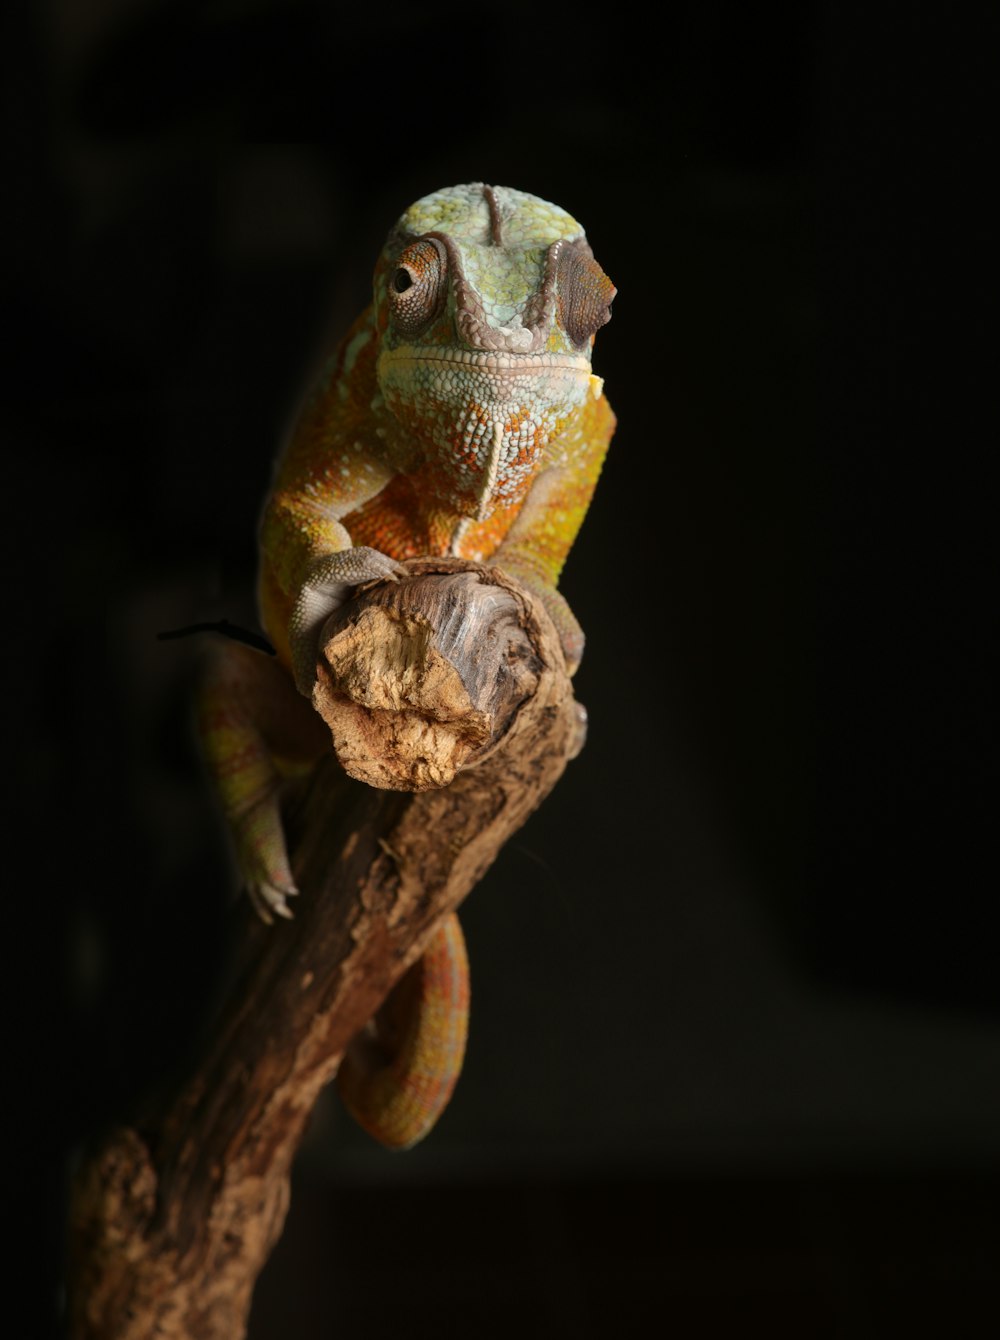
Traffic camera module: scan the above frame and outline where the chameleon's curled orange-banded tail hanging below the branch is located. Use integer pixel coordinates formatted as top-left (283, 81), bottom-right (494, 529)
top-left (336, 913), bottom-right (469, 1150)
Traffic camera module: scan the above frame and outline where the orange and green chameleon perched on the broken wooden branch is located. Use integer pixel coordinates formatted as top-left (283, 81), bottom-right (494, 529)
top-left (198, 182), bottom-right (617, 1148)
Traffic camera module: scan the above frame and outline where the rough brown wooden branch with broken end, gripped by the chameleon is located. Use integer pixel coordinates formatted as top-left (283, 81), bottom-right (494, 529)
top-left (70, 559), bottom-right (584, 1340)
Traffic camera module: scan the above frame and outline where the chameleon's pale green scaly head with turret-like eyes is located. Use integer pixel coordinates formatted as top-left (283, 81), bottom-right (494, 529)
top-left (375, 182), bottom-right (615, 520)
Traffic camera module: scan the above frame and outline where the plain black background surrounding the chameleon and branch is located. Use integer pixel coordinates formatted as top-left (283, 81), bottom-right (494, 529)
top-left (0, 0), bottom-right (1000, 1340)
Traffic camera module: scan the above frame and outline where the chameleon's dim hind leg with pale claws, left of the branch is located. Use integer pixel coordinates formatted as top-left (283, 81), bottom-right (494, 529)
top-left (197, 642), bottom-right (330, 922)
